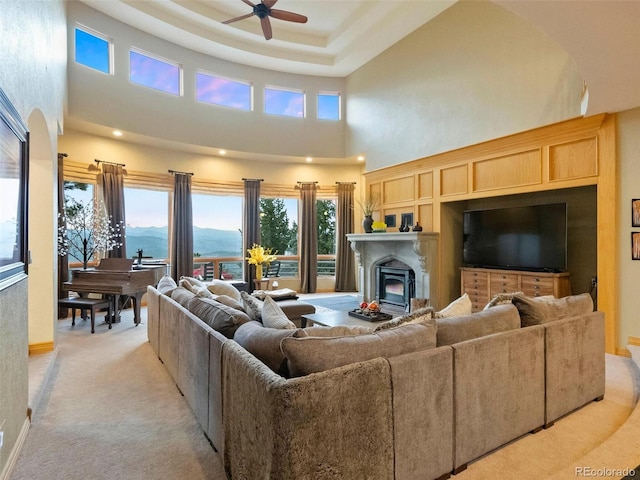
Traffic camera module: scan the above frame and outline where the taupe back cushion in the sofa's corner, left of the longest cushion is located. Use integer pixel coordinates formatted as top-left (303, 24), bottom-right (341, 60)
top-left (233, 320), bottom-right (297, 374)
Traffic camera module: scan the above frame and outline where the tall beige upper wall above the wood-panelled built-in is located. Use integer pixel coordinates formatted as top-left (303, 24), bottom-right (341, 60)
top-left (346, 2), bottom-right (582, 171)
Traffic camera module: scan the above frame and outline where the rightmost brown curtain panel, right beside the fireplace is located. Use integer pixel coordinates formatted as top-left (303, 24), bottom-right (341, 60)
top-left (335, 183), bottom-right (357, 292)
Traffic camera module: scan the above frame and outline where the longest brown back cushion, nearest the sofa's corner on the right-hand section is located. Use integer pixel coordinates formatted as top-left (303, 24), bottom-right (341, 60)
top-left (280, 320), bottom-right (436, 377)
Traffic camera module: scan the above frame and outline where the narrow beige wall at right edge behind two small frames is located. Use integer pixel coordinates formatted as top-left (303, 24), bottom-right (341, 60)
top-left (618, 108), bottom-right (640, 347)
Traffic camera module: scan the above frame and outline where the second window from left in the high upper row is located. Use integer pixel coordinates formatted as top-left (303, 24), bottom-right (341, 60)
top-left (129, 49), bottom-right (182, 96)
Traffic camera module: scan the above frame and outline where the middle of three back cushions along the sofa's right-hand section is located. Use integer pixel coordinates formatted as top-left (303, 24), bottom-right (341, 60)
top-left (436, 305), bottom-right (520, 347)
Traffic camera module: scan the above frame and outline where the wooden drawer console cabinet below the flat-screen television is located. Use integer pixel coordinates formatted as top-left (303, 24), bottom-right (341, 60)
top-left (460, 267), bottom-right (571, 312)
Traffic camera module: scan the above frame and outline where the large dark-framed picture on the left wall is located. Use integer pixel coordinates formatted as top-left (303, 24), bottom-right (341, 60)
top-left (0, 86), bottom-right (29, 289)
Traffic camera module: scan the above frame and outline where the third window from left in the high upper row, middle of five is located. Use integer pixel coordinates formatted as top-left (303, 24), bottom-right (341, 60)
top-left (196, 72), bottom-right (253, 111)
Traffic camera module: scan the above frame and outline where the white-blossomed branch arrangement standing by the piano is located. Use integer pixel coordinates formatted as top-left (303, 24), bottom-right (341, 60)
top-left (58, 199), bottom-right (125, 270)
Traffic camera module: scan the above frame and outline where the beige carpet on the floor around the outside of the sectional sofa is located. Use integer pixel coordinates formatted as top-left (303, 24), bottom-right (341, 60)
top-left (10, 309), bottom-right (640, 480)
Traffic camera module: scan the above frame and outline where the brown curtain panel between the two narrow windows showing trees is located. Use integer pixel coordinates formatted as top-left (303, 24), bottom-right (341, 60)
top-left (299, 183), bottom-right (318, 293)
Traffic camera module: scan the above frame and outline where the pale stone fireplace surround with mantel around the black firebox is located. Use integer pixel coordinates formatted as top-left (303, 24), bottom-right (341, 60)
top-left (347, 232), bottom-right (439, 304)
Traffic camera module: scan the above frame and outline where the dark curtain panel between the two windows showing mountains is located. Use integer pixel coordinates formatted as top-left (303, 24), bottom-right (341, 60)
top-left (171, 173), bottom-right (193, 282)
